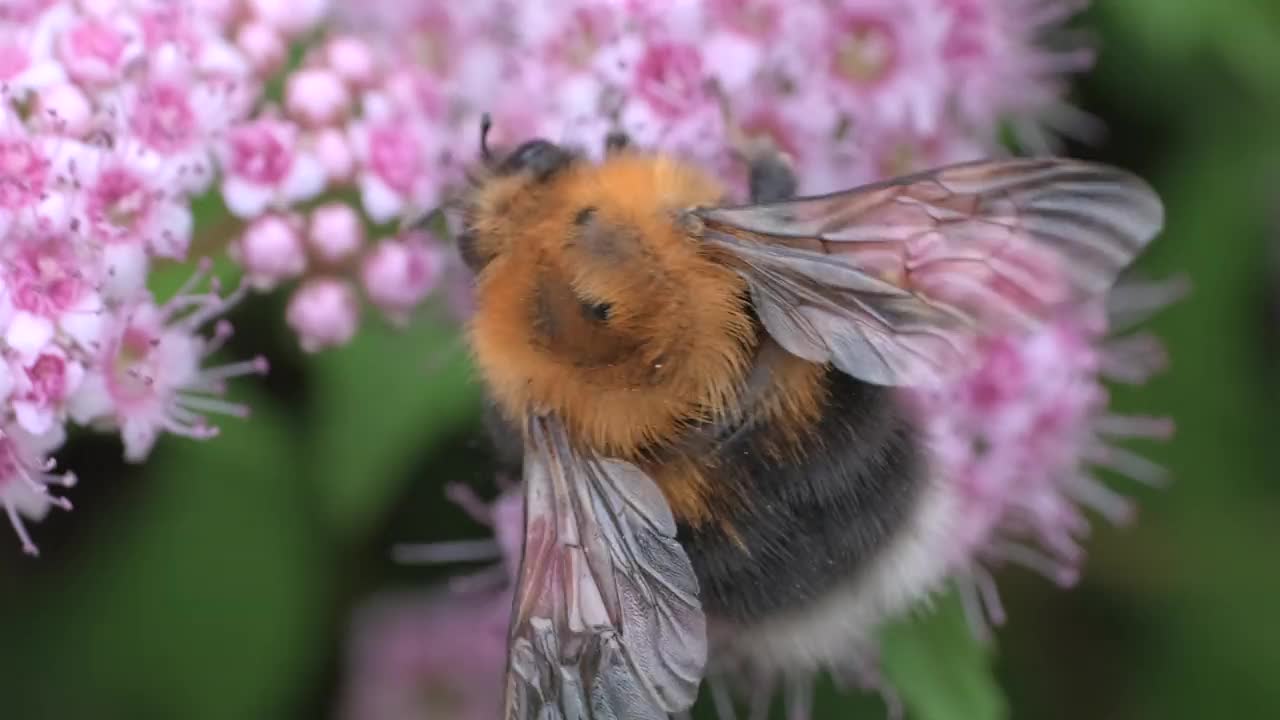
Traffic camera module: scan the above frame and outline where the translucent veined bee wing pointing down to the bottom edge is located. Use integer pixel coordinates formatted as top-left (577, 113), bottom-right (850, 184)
top-left (506, 416), bottom-right (707, 720)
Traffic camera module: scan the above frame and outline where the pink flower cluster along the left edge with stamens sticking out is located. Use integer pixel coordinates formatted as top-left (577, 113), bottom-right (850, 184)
top-left (0, 0), bottom-right (275, 553)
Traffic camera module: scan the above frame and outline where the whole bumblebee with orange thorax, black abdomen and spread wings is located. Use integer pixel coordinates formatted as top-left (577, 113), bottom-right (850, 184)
top-left (460, 120), bottom-right (1164, 719)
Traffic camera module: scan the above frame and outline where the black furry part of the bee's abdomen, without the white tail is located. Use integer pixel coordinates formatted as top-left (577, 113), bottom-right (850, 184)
top-left (680, 370), bottom-right (922, 623)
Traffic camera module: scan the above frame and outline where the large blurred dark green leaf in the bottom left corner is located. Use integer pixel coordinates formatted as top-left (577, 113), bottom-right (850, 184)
top-left (0, 389), bottom-right (333, 720)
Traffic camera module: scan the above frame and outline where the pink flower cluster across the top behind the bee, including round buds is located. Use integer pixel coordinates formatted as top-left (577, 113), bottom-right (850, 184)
top-left (259, 0), bottom-right (1091, 350)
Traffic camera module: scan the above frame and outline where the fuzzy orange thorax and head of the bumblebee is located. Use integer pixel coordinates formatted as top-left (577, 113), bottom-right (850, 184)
top-left (463, 140), bottom-right (751, 452)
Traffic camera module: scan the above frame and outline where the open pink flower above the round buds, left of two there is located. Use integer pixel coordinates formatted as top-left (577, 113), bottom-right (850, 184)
top-left (220, 118), bottom-right (325, 218)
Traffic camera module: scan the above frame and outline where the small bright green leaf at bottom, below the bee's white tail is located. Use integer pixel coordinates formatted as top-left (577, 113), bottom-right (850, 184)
top-left (882, 593), bottom-right (1009, 720)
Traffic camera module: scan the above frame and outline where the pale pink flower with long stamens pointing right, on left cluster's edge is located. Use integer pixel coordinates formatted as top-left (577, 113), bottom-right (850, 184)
top-left (69, 263), bottom-right (266, 462)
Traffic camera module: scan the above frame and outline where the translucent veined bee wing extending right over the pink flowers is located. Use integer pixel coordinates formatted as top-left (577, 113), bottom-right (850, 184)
top-left (694, 159), bottom-right (1164, 384)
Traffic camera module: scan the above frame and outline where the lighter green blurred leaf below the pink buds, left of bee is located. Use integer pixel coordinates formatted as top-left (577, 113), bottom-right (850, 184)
top-left (308, 311), bottom-right (480, 537)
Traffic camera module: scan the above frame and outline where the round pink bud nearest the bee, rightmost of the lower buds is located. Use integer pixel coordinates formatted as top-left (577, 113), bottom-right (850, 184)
top-left (360, 233), bottom-right (443, 322)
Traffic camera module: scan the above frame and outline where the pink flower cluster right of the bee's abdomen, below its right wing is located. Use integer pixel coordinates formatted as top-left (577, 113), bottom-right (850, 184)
top-left (906, 279), bottom-right (1184, 637)
